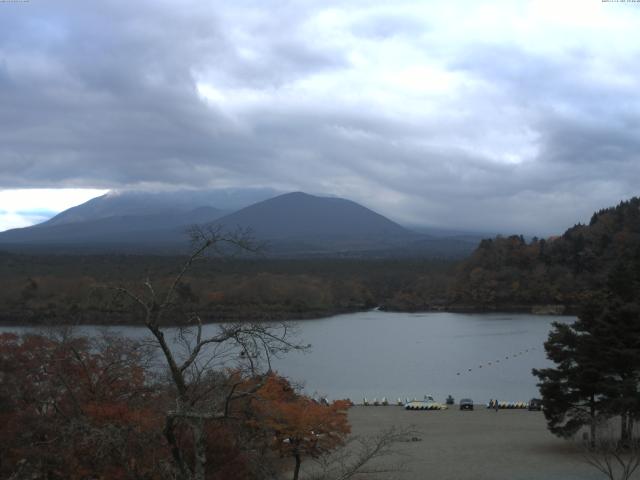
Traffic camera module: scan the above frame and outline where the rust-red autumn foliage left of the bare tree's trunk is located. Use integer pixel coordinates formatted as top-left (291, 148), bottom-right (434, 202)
top-left (0, 334), bottom-right (162, 480)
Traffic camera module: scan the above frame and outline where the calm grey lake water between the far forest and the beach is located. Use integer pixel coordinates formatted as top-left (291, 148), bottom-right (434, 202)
top-left (0, 311), bottom-right (574, 403)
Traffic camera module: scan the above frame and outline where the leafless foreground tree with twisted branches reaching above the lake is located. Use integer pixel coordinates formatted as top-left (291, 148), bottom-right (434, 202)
top-left (116, 228), bottom-right (304, 480)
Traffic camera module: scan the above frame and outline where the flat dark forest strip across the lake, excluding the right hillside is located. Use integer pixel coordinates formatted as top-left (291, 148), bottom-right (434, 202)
top-left (0, 253), bottom-right (455, 323)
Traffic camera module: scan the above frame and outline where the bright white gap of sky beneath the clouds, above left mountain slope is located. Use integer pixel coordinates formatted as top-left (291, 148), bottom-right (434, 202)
top-left (0, 188), bottom-right (108, 232)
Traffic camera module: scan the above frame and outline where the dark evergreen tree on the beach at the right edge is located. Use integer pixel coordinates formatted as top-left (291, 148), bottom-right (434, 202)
top-left (533, 252), bottom-right (640, 444)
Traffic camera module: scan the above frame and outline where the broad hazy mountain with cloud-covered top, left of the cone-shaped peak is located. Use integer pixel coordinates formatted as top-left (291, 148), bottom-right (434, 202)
top-left (0, 188), bottom-right (276, 253)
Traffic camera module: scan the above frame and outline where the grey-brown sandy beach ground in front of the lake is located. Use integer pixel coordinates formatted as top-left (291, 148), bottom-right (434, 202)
top-left (328, 405), bottom-right (616, 480)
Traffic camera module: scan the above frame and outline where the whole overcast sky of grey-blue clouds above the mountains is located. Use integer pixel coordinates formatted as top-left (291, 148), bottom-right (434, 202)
top-left (0, 0), bottom-right (640, 235)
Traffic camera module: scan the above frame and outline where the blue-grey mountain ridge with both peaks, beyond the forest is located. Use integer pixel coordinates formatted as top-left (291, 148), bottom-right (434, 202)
top-left (0, 190), bottom-right (475, 256)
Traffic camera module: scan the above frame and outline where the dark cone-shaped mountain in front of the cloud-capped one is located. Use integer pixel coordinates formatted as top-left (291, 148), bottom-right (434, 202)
top-left (210, 192), bottom-right (481, 258)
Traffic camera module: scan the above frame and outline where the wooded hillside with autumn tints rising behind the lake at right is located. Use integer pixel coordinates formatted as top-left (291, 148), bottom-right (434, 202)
top-left (450, 198), bottom-right (640, 310)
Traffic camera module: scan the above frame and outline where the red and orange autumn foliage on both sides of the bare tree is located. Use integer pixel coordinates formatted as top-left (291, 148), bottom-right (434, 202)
top-left (0, 334), bottom-right (349, 480)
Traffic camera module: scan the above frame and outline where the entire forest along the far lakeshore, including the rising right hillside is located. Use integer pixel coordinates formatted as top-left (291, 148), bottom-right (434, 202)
top-left (0, 198), bottom-right (640, 323)
